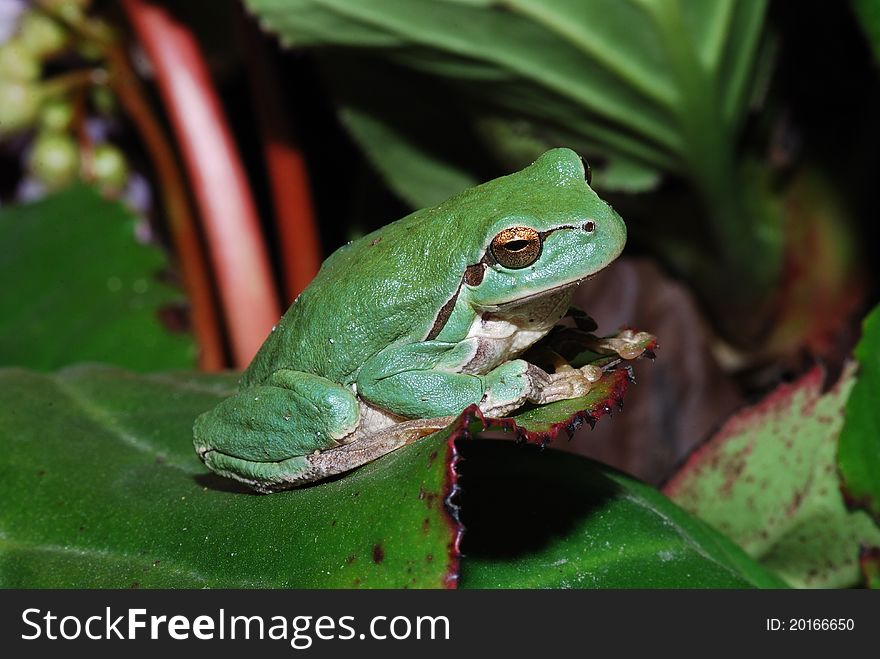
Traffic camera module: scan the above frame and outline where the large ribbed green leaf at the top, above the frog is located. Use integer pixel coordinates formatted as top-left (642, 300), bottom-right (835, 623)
top-left (246, 0), bottom-right (766, 200)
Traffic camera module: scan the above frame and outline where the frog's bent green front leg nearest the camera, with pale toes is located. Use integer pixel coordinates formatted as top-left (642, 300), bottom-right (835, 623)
top-left (357, 341), bottom-right (576, 418)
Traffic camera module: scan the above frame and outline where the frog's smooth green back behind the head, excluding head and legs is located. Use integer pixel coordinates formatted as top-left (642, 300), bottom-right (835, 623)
top-left (242, 209), bottom-right (474, 386)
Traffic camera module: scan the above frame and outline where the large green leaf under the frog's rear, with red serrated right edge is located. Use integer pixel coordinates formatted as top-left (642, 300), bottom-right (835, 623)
top-left (0, 367), bottom-right (457, 588)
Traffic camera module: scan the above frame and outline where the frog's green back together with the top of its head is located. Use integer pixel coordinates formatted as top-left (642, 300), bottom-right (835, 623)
top-left (235, 149), bottom-right (592, 386)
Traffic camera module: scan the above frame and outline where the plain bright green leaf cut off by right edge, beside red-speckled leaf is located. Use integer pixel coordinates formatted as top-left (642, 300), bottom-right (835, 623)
top-left (837, 307), bottom-right (880, 520)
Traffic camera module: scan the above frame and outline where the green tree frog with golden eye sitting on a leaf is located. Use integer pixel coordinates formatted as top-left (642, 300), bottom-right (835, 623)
top-left (194, 148), bottom-right (626, 492)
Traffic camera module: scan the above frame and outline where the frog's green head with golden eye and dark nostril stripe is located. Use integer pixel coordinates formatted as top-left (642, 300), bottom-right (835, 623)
top-left (454, 149), bottom-right (626, 310)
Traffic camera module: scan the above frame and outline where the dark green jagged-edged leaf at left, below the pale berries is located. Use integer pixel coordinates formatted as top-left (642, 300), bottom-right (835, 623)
top-left (0, 185), bottom-right (195, 370)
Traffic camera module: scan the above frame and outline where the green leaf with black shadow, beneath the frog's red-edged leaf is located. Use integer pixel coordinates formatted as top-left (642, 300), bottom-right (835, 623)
top-left (459, 441), bottom-right (785, 588)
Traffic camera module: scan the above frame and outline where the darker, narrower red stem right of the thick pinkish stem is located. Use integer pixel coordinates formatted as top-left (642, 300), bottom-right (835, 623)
top-left (245, 20), bottom-right (321, 302)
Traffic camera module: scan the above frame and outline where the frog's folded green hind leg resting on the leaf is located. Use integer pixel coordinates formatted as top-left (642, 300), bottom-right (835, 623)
top-left (193, 370), bottom-right (361, 491)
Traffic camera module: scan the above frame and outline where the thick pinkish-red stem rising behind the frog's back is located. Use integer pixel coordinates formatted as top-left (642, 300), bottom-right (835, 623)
top-left (123, 0), bottom-right (281, 367)
